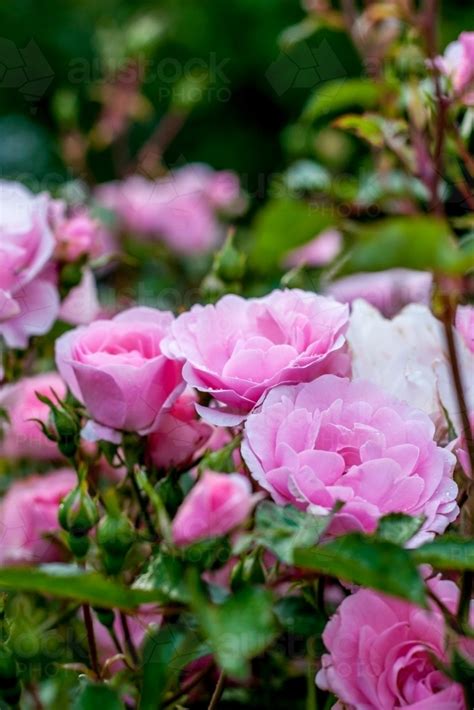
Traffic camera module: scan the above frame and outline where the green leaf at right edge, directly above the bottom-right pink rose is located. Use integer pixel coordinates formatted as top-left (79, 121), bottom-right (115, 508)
top-left (411, 534), bottom-right (474, 571)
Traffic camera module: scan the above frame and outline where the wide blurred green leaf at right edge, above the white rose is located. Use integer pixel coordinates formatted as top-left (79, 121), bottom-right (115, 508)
top-left (341, 215), bottom-right (474, 274)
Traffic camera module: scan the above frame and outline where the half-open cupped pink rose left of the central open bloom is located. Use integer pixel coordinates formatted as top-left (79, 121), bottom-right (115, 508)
top-left (56, 307), bottom-right (182, 438)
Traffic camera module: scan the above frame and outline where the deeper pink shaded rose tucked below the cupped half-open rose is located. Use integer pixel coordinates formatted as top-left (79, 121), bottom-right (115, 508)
top-left (148, 389), bottom-right (212, 468)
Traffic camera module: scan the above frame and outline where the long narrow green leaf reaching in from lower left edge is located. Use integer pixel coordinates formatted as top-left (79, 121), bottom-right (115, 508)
top-left (0, 564), bottom-right (167, 609)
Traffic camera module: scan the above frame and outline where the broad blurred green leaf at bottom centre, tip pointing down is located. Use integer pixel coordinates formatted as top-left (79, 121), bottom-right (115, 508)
top-left (192, 583), bottom-right (278, 678)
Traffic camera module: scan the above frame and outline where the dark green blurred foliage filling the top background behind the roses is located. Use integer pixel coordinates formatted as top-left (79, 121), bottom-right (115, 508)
top-left (0, 0), bottom-right (474, 202)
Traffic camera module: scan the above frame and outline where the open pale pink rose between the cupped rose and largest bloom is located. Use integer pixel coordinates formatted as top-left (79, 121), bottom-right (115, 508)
top-left (163, 289), bottom-right (350, 424)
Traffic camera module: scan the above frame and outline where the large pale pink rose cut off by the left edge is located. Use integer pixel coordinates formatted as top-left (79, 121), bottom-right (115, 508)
top-left (0, 180), bottom-right (59, 348)
